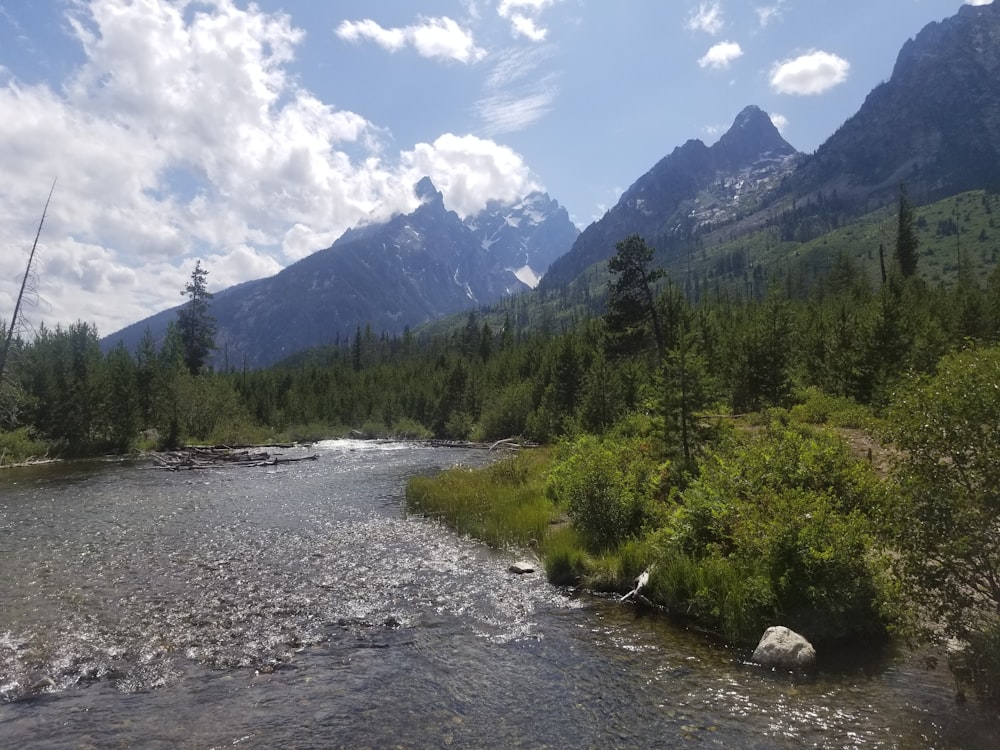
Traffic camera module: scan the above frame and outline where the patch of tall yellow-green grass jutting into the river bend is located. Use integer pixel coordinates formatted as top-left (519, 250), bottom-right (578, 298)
top-left (406, 451), bottom-right (556, 548)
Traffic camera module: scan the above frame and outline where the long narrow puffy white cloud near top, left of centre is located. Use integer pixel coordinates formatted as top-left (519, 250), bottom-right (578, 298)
top-left (334, 16), bottom-right (486, 63)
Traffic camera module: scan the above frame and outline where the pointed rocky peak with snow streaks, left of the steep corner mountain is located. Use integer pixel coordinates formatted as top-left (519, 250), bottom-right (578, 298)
top-left (541, 106), bottom-right (801, 288)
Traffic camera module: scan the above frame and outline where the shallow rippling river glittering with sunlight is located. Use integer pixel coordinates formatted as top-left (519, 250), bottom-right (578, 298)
top-left (0, 441), bottom-right (1000, 748)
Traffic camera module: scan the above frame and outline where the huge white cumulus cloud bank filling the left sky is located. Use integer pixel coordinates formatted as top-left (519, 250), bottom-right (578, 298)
top-left (0, 0), bottom-right (536, 334)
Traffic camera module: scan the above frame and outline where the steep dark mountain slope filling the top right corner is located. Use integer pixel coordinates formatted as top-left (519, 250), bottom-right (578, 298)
top-left (788, 2), bottom-right (1000, 207)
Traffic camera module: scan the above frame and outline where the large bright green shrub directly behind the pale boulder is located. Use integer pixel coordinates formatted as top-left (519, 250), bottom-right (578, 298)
top-left (652, 423), bottom-right (885, 642)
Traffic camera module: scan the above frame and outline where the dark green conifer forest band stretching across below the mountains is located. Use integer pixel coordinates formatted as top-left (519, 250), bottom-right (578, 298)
top-left (4, 196), bottom-right (1000, 459)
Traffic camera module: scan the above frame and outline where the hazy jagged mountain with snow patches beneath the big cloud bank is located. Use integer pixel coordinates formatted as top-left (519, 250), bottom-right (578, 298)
top-left (104, 182), bottom-right (579, 367)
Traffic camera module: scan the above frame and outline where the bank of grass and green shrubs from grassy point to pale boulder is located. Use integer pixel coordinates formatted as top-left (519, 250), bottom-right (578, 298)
top-left (407, 419), bottom-right (899, 645)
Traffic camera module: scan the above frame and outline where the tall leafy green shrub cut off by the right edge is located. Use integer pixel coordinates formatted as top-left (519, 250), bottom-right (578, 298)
top-left (886, 347), bottom-right (1000, 640)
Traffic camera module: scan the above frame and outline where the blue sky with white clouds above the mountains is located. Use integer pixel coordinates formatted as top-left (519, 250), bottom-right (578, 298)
top-left (0, 0), bottom-right (987, 336)
